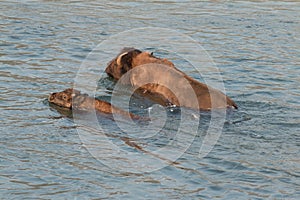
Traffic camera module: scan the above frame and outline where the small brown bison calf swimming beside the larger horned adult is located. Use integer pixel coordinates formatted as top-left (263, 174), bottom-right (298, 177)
top-left (48, 88), bottom-right (141, 119)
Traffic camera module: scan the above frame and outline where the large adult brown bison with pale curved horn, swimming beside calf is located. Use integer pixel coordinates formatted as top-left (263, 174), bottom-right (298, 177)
top-left (105, 48), bottom-right (237, 110)
